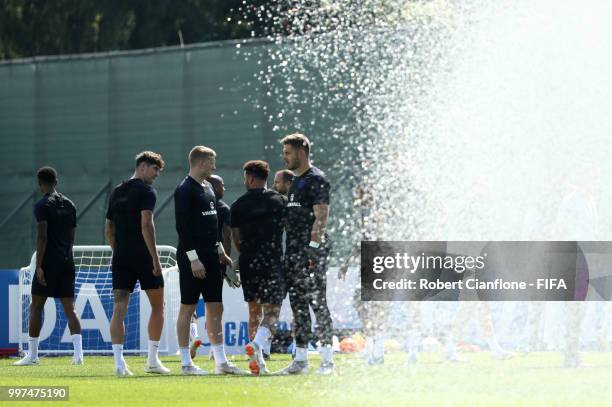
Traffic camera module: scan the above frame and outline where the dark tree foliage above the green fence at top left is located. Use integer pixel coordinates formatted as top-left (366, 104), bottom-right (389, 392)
top-left (0, 0), bottom-right (270, 59)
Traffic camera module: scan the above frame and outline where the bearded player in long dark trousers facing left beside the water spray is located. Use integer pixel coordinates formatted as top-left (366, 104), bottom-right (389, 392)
top-left (281, 134), bottom-right (334, 374)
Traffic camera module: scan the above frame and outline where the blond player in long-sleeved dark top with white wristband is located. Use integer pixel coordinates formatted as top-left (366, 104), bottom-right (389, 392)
top-left (174, 146), bottom-right (247, 376)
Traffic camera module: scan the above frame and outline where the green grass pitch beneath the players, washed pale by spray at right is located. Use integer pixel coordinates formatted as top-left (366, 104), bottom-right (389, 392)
top-left (0, 352), bottom-right (612, 407)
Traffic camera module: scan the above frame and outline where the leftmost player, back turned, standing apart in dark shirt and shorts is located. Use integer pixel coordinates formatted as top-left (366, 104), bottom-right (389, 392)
top-left (14, 167), bottom-right (83, 366)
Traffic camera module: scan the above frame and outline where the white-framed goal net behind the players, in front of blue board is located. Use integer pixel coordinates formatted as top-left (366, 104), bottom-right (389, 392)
top-left (19, 246), bottom-right (180, 354)
